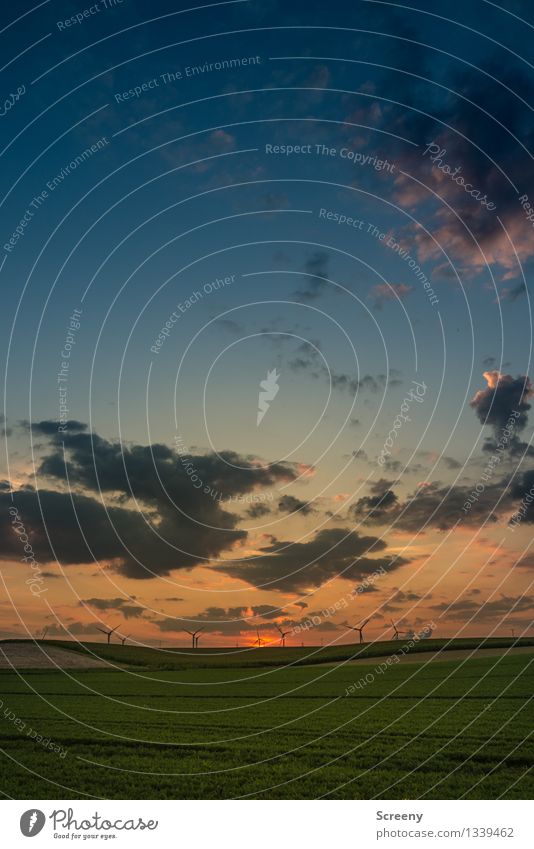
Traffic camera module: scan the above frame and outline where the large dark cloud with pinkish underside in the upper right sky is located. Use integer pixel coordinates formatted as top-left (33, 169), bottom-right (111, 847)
top-left (387, 56), bottom-right (534, 279)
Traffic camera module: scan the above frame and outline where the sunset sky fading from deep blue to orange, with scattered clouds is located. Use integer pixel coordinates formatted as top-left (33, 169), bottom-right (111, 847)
top-left (0, 0), bottom-right (534, 648)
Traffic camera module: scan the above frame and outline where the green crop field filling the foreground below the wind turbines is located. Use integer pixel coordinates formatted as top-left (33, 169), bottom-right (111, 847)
top-left (0, 640), bottom-right (534, 799)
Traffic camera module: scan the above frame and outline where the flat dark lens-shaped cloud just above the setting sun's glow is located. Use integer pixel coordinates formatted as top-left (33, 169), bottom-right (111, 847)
top-left (218, 528), bottom-right (409, 592)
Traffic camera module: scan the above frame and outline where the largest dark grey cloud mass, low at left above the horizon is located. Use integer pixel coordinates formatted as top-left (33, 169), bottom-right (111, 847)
top-left (0, 422), bottom-right (297, 578)
